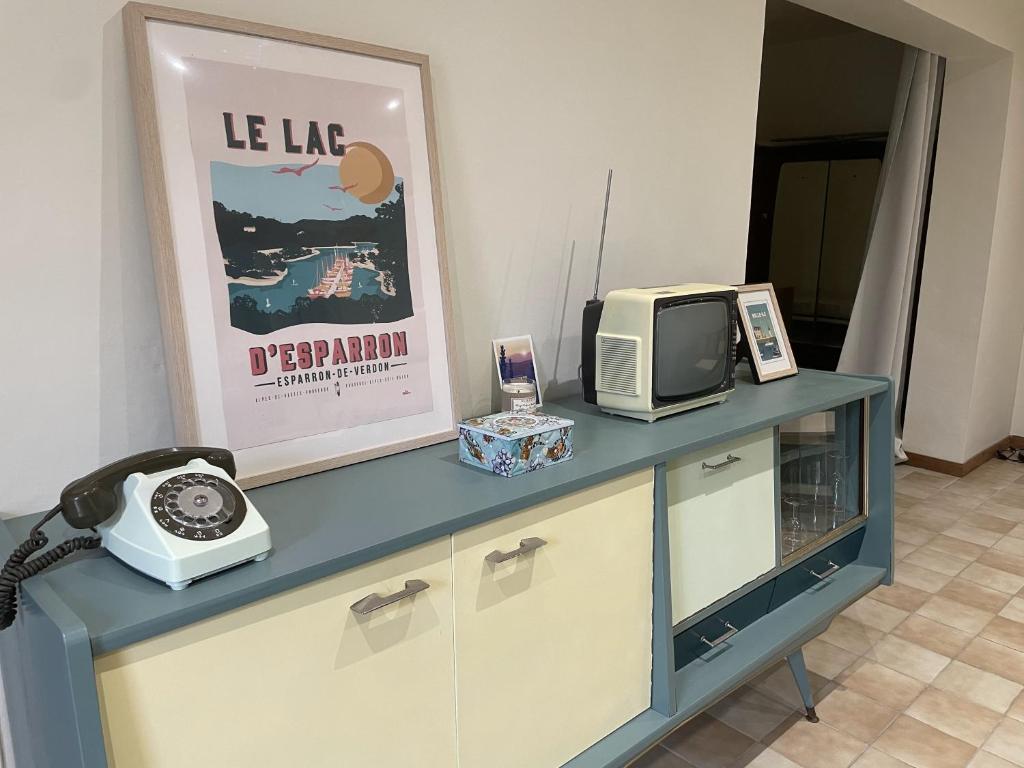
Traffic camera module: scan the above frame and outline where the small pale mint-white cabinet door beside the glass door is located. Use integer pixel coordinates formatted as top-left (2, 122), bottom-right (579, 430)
top-left (667, 429), bottom-right (776, 624)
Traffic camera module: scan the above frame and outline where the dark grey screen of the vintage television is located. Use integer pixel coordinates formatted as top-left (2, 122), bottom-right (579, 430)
top-left (654, 298), bottom-right (732, 400)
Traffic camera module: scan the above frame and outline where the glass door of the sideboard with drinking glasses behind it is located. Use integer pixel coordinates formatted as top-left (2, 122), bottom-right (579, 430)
top-left (779, 400), bottom-right (866, 558)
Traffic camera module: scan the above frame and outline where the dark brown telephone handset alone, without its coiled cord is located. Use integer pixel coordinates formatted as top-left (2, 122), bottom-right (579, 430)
top-left (60, 447), bottom-right (234, 528)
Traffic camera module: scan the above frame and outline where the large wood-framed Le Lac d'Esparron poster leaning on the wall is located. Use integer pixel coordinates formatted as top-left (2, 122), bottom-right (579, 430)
top-left (124, 3), bottom-right (458, 487)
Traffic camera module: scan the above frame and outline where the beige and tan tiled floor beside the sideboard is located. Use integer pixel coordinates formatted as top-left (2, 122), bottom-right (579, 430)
top-left (634, 460), bottom-right (1024, 768)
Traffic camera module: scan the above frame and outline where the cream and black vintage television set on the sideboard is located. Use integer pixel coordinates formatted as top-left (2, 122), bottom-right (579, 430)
top-left (581, 283), bottom-right (737, 422)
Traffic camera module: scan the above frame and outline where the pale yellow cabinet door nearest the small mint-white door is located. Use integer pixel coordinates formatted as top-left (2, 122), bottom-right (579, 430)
top-left (454, 470), bottom-right (653, 768)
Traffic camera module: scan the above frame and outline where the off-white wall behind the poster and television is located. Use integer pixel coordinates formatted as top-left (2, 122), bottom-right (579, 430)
top-left (0, 0), bottom-right (763, 514)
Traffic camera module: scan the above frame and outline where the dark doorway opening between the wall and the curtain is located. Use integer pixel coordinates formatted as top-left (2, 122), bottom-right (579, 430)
top-left (745, 0), bottom-right (904, 371)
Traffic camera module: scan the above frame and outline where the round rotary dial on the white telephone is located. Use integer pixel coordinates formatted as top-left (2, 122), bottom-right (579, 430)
top-left (151, 472), bottom-right (246, 541)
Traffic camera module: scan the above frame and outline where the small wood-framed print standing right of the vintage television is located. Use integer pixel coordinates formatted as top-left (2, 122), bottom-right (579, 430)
top-left (736, 283), bottom-right (799, 384)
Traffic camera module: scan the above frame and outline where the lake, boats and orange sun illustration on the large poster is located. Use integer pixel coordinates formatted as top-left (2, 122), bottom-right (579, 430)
top-left (210, 141), bottom-right (413, 334)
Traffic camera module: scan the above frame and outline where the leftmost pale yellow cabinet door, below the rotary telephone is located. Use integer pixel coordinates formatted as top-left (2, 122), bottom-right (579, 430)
top-left (96, 538), bottom-right (457, 768)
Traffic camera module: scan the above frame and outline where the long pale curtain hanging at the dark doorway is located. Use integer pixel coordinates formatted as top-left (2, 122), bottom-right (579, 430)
top-left (837, 47), bottom-right (944, 460)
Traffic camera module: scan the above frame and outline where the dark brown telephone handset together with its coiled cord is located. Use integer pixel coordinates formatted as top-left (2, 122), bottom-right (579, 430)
top-left (0, 447), bottom-right (234, 630)
